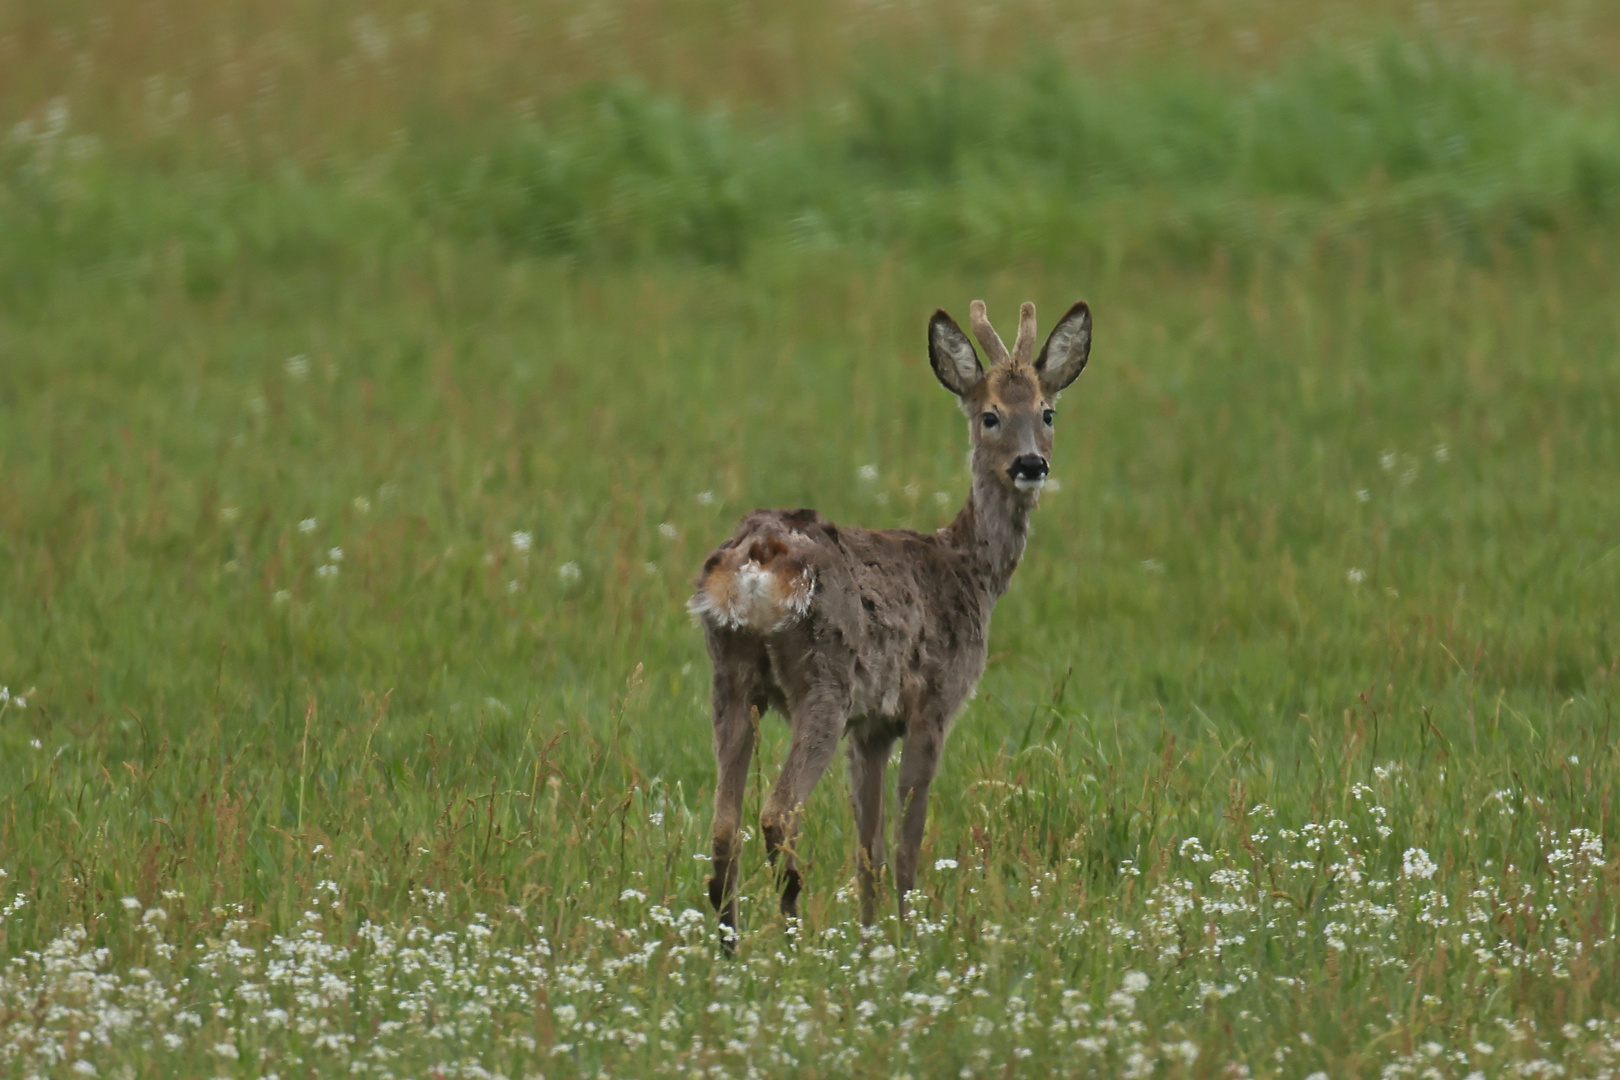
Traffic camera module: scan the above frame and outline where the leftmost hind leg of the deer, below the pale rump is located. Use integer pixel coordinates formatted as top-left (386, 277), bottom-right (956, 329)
top-left (710, 631), bottom-right (765, 949)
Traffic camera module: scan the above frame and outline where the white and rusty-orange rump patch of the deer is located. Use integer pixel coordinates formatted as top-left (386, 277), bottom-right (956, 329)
top-left (687, 531), bottom-right (815, 633)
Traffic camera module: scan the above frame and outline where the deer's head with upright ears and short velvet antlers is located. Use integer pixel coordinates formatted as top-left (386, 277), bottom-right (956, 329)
top-left (928, 300), bottom-right (1092, 500)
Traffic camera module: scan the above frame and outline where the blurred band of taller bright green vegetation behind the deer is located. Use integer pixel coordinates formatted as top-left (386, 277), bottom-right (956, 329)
top-left (9, 37), bottom-right (1620, 284)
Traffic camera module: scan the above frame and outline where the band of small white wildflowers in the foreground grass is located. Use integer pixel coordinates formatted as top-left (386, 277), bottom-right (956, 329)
top-left (0, 786), bottom-right (1620, 1080)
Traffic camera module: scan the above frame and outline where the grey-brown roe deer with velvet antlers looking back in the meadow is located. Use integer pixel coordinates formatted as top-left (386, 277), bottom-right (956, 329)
top-left (690, 300), bottom-right (1092, 946)
